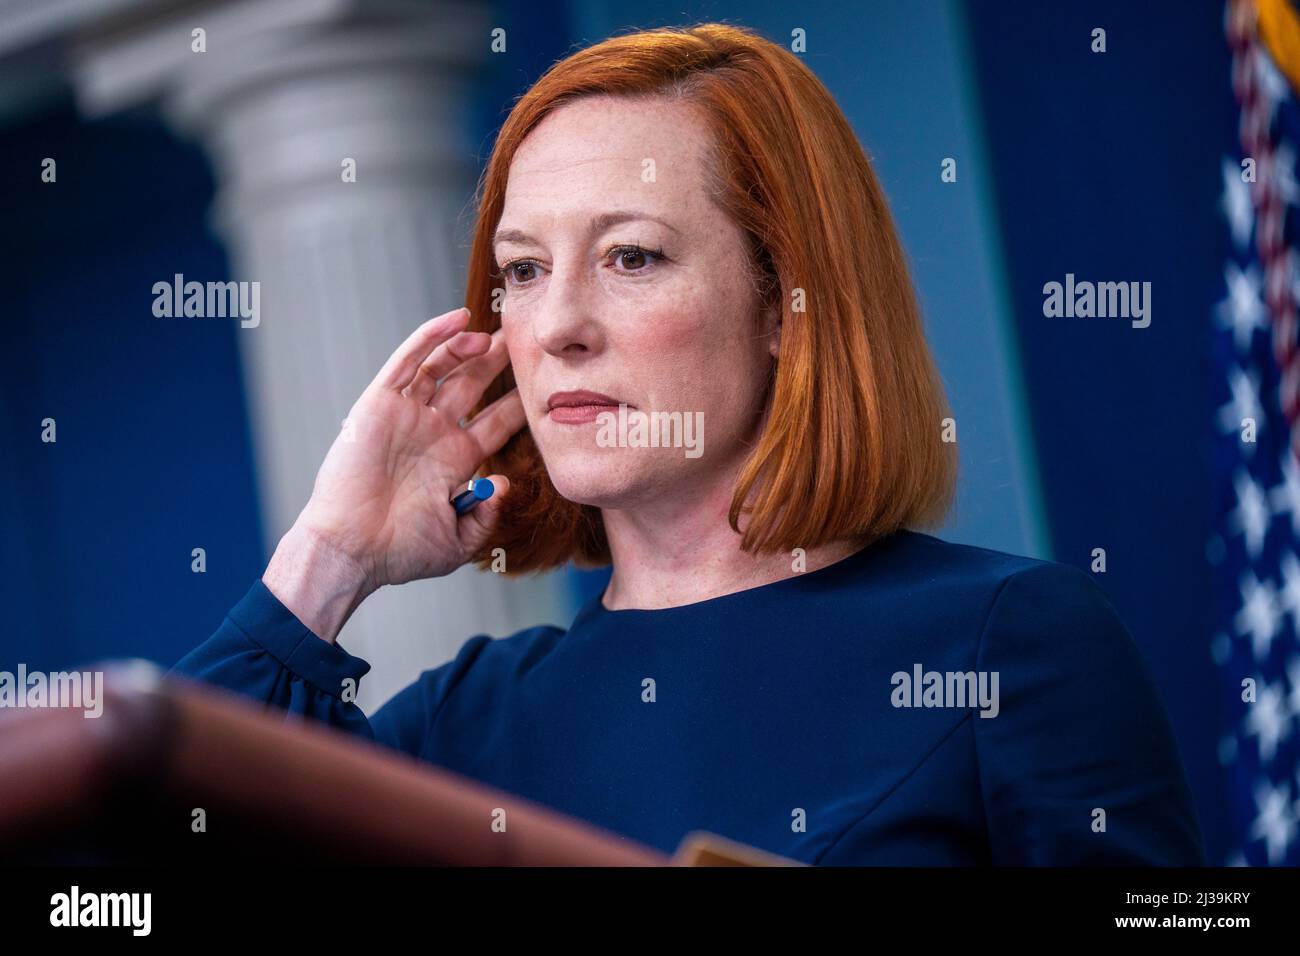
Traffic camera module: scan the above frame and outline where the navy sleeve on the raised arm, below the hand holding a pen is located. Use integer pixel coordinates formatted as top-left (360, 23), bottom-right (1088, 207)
top-left (172, 580), bottom-right (489, 756)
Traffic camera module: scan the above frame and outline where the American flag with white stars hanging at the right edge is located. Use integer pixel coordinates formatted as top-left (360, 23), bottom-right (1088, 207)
top-left (1209, 0), bottom-right (1300, 866)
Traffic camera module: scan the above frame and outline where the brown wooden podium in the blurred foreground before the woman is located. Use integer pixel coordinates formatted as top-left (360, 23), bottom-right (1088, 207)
top-left (0, 667), bottom-right (802, 866)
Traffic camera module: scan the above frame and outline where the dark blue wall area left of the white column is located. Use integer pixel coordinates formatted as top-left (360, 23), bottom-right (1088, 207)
top-left (0, 104), bottom-right (264, 670)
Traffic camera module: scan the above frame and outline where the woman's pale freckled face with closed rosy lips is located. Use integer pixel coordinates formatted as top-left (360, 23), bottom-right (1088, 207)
top-left (494, 96), bottom-right (777, 509)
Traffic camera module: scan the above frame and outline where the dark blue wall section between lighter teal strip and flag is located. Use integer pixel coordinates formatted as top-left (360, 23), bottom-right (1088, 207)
top-left (970, 0), bottom-right (1235, 860)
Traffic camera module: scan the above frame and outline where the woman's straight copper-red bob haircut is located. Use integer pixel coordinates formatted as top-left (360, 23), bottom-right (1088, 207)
top-left (465, 23), bottom-right (957, 575)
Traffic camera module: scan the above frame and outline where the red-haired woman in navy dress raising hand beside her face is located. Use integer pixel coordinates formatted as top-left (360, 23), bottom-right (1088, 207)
top-left (178, 25), bottom-right (1204, 864)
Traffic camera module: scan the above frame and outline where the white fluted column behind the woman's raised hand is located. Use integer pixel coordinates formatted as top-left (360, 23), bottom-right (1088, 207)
top-left (61, 3), bottom-right (572, 711)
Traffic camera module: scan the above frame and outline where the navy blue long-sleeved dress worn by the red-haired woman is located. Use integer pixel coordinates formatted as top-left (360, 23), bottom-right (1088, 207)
top-left (176, 531), bottom-right (1205, 865)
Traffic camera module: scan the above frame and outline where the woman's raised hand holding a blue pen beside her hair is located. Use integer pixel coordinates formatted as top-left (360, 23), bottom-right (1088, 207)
top-left (263, 308), bottom-right (525, 641)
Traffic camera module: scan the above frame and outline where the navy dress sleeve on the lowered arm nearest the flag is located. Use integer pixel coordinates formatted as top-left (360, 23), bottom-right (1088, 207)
top-left (972, 562), bottom-right (1205, 866)
